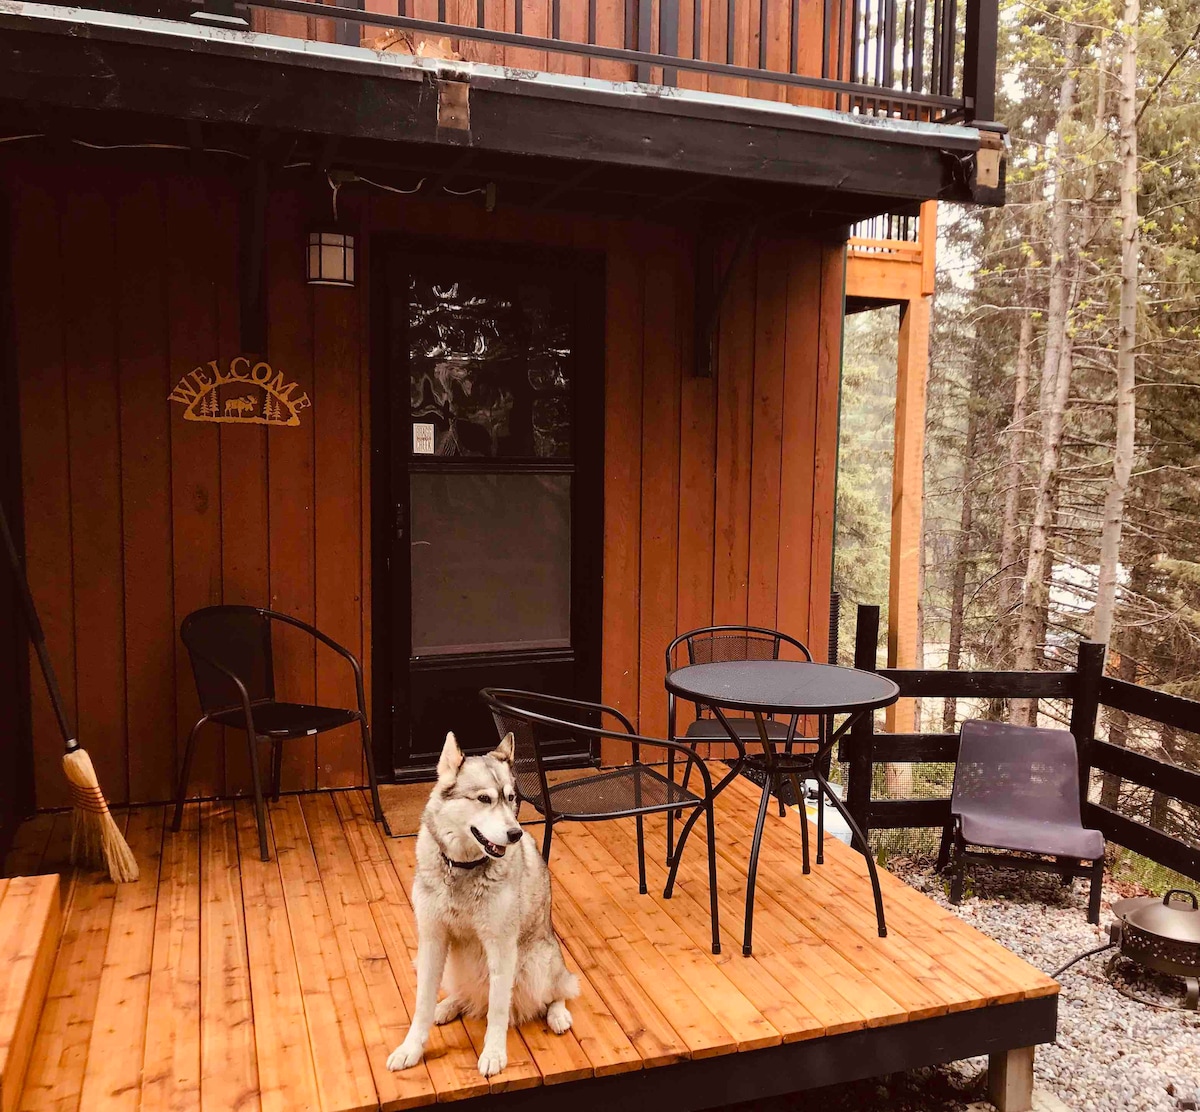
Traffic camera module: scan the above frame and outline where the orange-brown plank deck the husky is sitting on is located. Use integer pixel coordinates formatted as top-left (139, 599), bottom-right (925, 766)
top-left (8, 780), bottom-right (1057, 1112)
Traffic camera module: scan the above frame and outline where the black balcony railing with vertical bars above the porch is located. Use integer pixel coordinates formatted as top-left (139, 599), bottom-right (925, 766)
top-left (180, 0), bottom-right (998, 122)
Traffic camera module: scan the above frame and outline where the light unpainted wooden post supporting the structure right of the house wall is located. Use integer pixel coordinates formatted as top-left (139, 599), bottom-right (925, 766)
top-left (887, 291), bottom-right (930, 733)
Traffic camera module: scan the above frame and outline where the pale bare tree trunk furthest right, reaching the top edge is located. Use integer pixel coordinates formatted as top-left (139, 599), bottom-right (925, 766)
top-left (1092, 0), bottom-right (1141, 643)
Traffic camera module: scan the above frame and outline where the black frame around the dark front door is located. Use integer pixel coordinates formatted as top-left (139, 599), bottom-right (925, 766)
top-left (368, 233), bottom-right (606, 781)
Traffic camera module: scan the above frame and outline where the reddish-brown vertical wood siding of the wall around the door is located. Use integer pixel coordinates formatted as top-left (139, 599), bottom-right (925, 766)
top-left (0, 149), bottom-right (844, 807)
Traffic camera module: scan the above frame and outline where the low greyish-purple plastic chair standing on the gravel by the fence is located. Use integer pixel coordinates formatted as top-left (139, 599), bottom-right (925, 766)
top-left (938, 720), bottom-right (1104, 922)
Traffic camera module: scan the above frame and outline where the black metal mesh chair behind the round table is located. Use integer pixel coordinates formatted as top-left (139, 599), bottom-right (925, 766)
top-left (667, 625), bottom-right (824, 858)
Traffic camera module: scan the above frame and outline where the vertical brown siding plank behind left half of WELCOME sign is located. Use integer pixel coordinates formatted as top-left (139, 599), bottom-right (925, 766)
top-left (166, 176), bottom-right (224, 797)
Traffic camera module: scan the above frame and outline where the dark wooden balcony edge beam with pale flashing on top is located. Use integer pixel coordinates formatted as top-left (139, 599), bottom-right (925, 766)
top-left (0, 0), bottom-right (1003, 221)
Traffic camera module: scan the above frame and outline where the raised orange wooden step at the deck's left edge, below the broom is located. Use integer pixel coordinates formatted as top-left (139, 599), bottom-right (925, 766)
top-left (0, 874), bottom-right (62, 1112)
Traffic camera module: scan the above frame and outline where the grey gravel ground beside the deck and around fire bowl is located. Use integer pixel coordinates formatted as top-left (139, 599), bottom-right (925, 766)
top-left (892, 861), bottom-right (1200, 1112)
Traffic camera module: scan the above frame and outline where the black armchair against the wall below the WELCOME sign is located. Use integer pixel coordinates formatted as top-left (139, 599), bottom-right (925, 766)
top-left (172, 606), bottom-right (391, 861)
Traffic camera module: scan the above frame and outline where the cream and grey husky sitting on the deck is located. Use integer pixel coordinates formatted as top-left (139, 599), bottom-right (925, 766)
top-left (388, 734), bottom-right (580, 1077)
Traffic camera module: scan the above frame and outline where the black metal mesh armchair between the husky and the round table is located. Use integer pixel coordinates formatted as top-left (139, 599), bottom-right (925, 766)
top-left (480, 687), bottom-right (721, 954)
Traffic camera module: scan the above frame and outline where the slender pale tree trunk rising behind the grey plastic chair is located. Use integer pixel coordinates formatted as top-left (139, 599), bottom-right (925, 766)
top-left (1012, 23), bottom-right (1080, 725)
